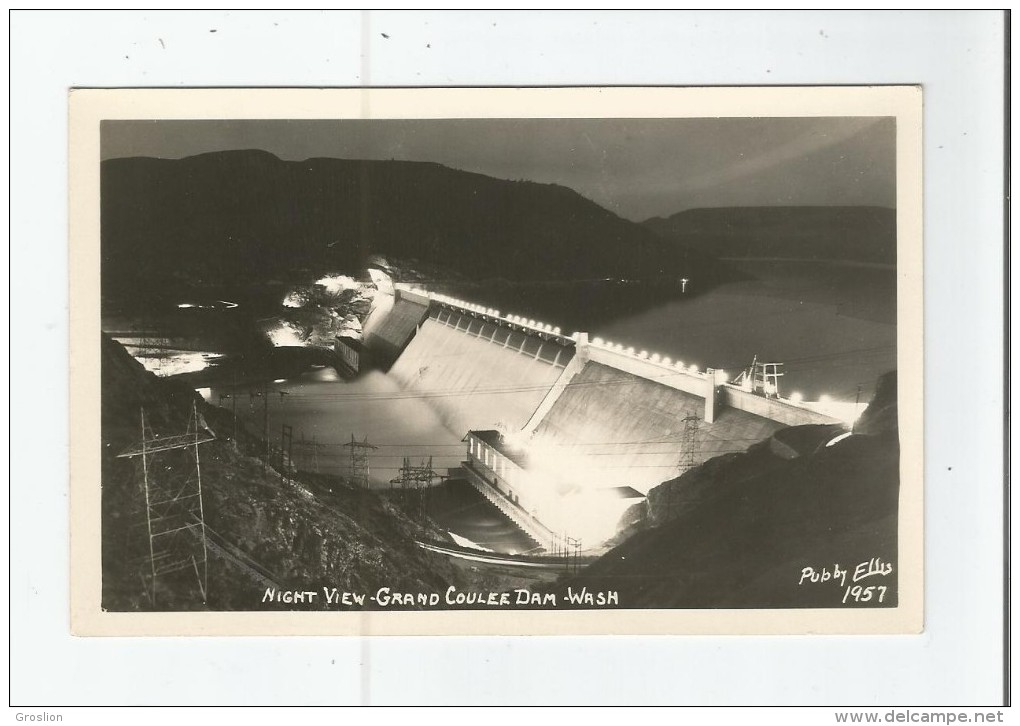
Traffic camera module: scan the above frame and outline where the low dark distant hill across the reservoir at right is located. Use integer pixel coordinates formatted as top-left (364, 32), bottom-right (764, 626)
top-left (642, 206), bottom-right (897, 264)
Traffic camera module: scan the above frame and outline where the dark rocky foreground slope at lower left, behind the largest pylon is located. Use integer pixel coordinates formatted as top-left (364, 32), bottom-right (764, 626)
top-left (102, 338), bottom-right (459, 611)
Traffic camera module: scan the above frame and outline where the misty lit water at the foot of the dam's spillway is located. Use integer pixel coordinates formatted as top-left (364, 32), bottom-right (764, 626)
top-left (209, 368), bottom-right (465, 488)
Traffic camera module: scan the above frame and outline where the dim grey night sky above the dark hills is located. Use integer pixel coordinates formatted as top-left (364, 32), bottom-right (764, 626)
top-left (102, 117), bottom-right (896, 221)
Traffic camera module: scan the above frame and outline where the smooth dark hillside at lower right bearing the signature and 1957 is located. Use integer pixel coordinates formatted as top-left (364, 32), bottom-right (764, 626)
top-left (568, 374), bottom-right (900, 608)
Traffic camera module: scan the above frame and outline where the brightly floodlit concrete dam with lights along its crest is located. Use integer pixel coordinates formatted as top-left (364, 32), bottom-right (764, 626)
top-left (364, 284), bottom-right (840, 550)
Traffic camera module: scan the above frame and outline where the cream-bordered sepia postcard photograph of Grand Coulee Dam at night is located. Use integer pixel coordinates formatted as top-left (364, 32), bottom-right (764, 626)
top-left (71, 87), bottom-right (922, 633)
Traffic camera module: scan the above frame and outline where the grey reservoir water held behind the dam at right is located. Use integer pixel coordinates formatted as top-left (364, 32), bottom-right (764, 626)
top-left (593, 263), bottom-right (897, 402)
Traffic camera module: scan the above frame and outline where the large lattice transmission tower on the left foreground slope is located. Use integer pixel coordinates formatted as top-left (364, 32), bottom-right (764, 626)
top-left (117, 401), bottom-right (214, 607)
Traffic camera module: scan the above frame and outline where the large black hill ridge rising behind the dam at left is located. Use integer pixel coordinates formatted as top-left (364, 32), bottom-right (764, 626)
top-left (101, 150), bottom-right (710, 289)
